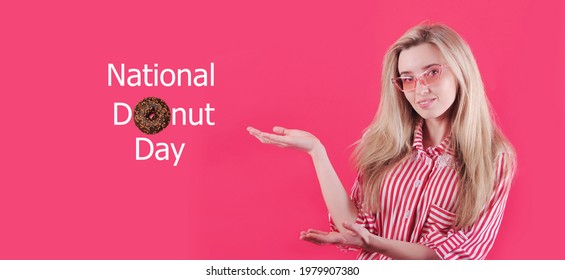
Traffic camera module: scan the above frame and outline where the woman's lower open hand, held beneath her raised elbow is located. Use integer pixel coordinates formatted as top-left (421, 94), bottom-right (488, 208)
top-left (300, 222), bottom-right (371, 250)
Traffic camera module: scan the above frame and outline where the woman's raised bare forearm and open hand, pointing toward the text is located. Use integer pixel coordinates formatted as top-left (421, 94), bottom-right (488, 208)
top-left (247, 126), bottom-right (357, 231)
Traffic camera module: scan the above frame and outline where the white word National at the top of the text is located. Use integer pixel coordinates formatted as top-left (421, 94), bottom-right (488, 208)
top-left (108, 62), bottom-right (214, 87)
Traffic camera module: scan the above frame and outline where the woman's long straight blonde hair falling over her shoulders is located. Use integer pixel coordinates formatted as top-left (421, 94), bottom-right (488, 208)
top-left (354, 23), bottom-right (514, 228)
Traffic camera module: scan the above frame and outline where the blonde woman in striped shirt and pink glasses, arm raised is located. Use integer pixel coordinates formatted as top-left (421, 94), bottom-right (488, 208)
top-left (248, 23), bottom-right (516, 259)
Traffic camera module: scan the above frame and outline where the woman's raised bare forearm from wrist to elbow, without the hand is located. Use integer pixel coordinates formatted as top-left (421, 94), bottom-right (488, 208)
top-left (310, 142), bottom-right (357, 232)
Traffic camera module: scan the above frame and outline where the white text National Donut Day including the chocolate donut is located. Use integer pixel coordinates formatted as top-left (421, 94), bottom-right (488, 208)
top-left (108, 62), bottom-right (215, 166)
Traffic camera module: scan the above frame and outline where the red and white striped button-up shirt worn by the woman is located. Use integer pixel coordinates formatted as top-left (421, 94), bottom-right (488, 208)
top-left (331, 121), bottom-right (514, 260)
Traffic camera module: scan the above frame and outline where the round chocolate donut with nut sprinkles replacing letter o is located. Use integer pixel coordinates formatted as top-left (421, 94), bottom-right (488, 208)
top-left (134, 97), bottom-right (171, 134)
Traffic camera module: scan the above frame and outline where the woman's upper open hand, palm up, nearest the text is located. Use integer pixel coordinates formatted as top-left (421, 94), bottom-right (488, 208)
top-left (247, 126), bottom-right (324, 156)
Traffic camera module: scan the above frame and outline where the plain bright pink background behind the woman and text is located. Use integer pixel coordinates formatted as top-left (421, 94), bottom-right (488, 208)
top-left (0, 0), bottom-right (565, 259)
